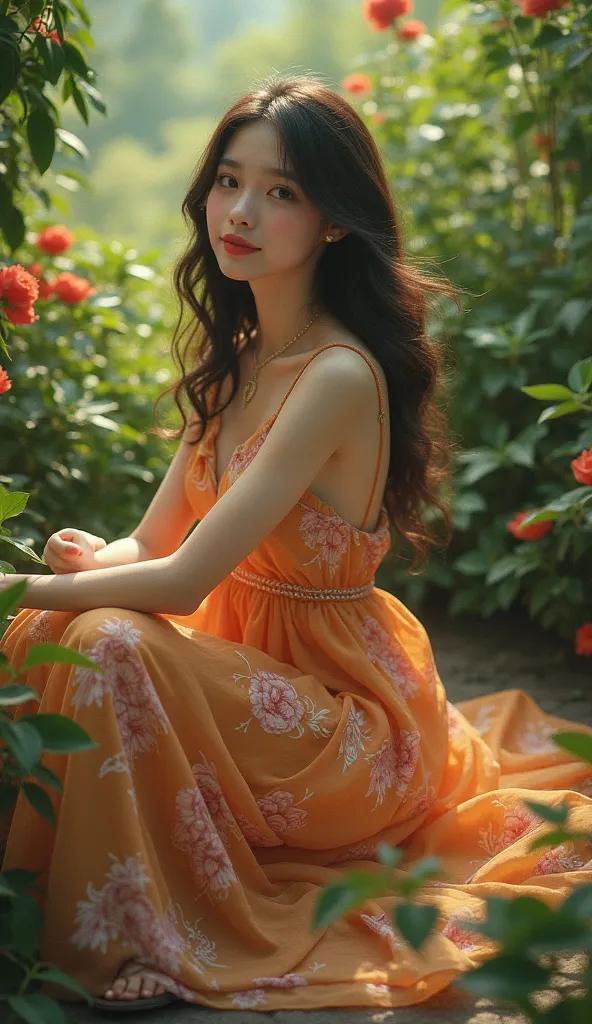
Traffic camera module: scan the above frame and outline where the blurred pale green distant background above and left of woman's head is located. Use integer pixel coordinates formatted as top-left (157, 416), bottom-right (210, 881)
top-left (52, 0), bottom-right (439, 254)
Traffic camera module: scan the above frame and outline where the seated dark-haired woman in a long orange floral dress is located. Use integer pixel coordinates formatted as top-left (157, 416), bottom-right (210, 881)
top-left (3, 77), bottom-right (592, 1011)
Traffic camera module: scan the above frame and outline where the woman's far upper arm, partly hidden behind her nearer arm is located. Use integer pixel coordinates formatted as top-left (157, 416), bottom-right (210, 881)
top-left (130, 428), bottom-right (198, 558)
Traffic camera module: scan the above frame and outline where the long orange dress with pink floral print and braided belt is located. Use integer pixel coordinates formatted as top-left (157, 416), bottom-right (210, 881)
top-left (0, 346), bottom-right (592, 1012)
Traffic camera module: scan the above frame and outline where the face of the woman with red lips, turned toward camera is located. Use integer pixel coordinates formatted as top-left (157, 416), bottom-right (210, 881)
top-left (206, 121), bottom-right (327, 281)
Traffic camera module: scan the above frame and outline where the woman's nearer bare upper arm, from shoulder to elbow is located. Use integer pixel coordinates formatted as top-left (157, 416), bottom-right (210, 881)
top-left (167, 349), bottom-right (376, 613)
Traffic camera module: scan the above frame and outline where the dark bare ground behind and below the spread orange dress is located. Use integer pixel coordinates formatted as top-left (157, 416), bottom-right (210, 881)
top-left (65, 604), bottom-right (592, 1024)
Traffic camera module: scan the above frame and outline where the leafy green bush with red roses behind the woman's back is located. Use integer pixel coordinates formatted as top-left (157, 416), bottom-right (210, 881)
top-left (342, 0), bottom-right (592, 654)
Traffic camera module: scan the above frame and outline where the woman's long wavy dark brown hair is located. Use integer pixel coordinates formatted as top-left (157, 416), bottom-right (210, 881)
top-left (151, 74), bottom-right (460, 574)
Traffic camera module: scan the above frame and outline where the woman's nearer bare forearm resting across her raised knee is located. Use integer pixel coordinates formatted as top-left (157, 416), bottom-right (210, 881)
top-left (17, 556), bottom-right (187, 615)
